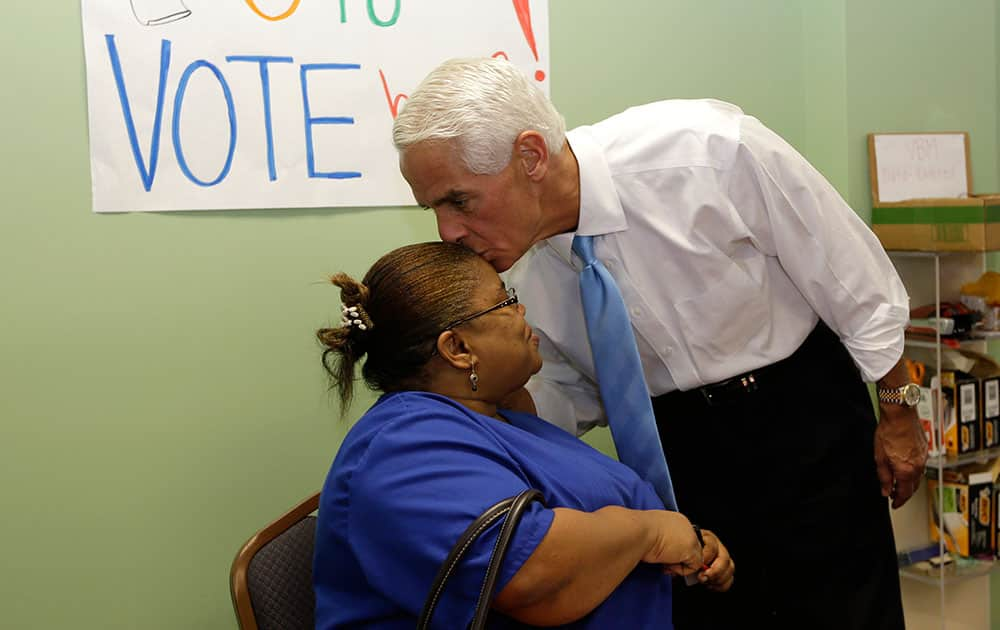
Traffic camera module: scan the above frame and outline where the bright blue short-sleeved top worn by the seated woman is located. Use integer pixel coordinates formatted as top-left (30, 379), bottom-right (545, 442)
top-left (313, 392), bottom-right (672, 630)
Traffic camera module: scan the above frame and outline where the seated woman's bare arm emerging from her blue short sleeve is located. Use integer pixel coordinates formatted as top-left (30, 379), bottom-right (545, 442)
top-left (493, 506), bottom-right (702, 626)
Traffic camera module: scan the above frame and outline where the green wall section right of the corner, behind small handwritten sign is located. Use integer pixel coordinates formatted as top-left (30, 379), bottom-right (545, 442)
top-left (846, 0), bottom-right (1000, 216)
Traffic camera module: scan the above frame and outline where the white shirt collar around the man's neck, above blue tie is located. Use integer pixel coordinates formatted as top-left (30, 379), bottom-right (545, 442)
top-left (546, 127), bottom-right (628, 262)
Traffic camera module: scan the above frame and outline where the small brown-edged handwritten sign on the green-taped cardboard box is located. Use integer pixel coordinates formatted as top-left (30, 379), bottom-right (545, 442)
top-left (868, 132), bottom-right (972, 204)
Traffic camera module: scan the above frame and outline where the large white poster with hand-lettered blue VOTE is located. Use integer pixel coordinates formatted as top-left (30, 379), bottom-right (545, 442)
top-left (82, 0), bottom-right (550, 212)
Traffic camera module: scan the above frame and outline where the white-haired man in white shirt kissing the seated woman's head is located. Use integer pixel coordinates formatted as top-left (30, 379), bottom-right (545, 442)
top-left (393, 59), bottom-right (927, 629)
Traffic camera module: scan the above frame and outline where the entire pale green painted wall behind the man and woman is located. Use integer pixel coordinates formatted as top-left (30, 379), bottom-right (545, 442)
top-left (0, 0), bottom-right (1000, 630)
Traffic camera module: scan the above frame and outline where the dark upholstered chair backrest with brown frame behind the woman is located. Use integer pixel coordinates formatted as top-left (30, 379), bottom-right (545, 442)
top-left (229, 492), bottom-right (319, 630)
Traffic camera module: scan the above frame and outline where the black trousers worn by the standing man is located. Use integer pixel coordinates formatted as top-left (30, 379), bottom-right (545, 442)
top-left (653, 322), bottom-right (903, 630)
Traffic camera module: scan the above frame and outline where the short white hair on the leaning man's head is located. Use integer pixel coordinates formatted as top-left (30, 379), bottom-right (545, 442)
top-left (392, 57), bottom-right (566, 175)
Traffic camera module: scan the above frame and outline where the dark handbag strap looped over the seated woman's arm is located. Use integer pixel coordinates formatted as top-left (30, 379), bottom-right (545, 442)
top-left (417, 488), bottom-right (542, 630)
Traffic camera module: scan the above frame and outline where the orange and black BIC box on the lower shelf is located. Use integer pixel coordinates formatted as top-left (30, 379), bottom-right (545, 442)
top-left (927, 466), bottom-right (996, 556)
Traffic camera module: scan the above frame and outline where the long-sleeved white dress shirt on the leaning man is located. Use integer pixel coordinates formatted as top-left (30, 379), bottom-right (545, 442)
top-left (505, 100), bottom-right (909, 434)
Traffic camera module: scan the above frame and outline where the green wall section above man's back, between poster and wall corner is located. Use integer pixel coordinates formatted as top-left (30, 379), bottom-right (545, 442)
top-left (550, 0), bottom-right (805, 143)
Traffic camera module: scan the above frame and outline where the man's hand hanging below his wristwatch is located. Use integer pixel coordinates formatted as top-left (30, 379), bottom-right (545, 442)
top-left (875, 403), bottom-right (927, 509)
